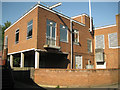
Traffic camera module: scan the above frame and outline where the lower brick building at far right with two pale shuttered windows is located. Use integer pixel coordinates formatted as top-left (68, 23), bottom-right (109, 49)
top-left (94, 15), bottom-right (120, 68)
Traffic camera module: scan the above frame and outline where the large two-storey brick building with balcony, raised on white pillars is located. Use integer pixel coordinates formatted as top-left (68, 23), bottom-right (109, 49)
top-left (4, 4), bottom-right (94, 69)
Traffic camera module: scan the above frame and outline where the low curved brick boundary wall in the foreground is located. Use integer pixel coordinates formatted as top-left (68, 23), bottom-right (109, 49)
top-left (34, 69), bottom-right (120, 87)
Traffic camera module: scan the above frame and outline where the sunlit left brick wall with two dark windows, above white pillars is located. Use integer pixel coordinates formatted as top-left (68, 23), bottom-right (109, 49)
top-left (4, 8), bottom-right (38, 53)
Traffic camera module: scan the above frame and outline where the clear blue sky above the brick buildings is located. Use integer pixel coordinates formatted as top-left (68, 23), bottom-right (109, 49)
top-left (2, 2), bottom-right (118, 27)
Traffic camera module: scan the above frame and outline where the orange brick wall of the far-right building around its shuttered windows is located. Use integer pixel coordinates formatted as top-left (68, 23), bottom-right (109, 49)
top-left (94, 15), bottom-right (120, 68)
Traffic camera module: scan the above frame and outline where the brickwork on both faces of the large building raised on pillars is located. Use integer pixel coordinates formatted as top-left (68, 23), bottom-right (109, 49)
top-left (5, 4), bottom-right (94, 68)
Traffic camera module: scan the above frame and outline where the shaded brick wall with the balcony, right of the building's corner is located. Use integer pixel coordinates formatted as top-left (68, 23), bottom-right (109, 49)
top-left (37, 8), bottom-right (94, 68)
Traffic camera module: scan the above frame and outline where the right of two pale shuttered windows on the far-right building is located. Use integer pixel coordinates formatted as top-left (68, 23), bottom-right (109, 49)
top-left (108, 33), bottom-right (118, 48)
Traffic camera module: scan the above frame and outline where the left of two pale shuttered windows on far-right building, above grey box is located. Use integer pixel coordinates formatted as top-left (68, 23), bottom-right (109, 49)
top-left (95, 35), bottom-right (105, 49)
